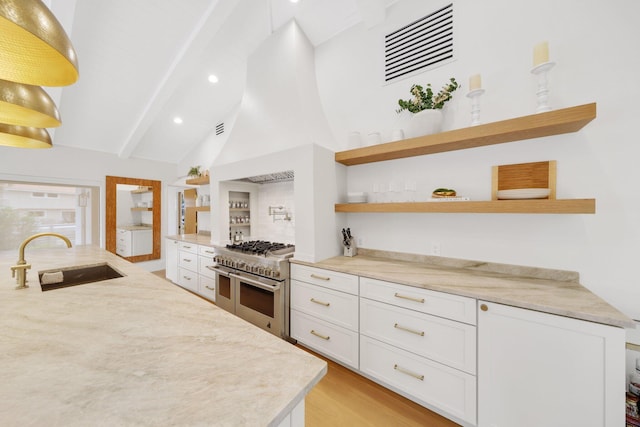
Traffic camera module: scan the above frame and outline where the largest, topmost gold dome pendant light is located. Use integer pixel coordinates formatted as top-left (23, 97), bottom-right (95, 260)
top-left (0, 0), bottom-right (78, 86)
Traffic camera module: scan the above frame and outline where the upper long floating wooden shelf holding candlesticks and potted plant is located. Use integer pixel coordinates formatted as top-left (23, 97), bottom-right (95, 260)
top-left (335, 103), bottom-right (596, 166)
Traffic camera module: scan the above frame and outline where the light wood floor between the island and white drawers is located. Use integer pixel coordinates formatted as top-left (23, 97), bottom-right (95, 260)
top-left (298, 346), bottom-right (458, 427)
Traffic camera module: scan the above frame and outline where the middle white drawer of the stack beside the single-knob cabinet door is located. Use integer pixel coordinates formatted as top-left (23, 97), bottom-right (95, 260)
top-left (360, 298), bottom-right (476, 374)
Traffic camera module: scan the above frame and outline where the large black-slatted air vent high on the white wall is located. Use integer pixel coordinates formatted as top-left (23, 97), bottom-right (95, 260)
top-left (384, 3), bottom-right (453, 83)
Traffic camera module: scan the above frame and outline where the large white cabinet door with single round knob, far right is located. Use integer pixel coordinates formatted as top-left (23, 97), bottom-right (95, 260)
top-left (478, 301), bottom-right (625, 427)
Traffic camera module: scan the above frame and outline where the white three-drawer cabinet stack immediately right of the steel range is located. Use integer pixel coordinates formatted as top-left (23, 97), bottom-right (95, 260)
top-left (291, 264), bottom-right (359, 369)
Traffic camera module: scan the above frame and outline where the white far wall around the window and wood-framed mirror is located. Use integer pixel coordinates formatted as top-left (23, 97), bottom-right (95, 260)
top-left (0, 145), bottom-right (176, 271)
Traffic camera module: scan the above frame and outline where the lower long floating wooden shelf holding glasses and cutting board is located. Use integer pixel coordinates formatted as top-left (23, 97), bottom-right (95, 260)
top-left (335, 199), bottom-right (596, 214)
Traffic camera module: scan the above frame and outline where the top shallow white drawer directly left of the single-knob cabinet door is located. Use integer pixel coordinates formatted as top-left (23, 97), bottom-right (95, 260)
top-left (360, 277), bottom-right (476, 325)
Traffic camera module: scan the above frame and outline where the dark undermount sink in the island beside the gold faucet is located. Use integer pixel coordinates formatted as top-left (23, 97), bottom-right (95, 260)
top-left (38, 262), bottom-right (124, 292)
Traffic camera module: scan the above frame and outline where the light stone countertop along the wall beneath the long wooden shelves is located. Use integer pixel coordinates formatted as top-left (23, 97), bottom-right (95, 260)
top-left (291, 249), bottom-right (635, 328)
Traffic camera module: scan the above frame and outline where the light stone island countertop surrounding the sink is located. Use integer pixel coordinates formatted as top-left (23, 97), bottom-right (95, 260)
top-left (0, 246), bottom-right (327, 426)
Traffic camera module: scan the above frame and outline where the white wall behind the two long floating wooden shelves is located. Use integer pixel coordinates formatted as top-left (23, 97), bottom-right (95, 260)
top-left (316, 0), bottom-right (640, 319)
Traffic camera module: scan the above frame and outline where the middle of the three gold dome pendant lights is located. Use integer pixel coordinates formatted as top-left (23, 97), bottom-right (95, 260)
top-left (0, 80), bottom-right (61, 128)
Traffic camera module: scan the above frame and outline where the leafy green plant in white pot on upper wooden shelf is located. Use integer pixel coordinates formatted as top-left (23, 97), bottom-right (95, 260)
top-left (396, 77), bottom-right (459, 136)
